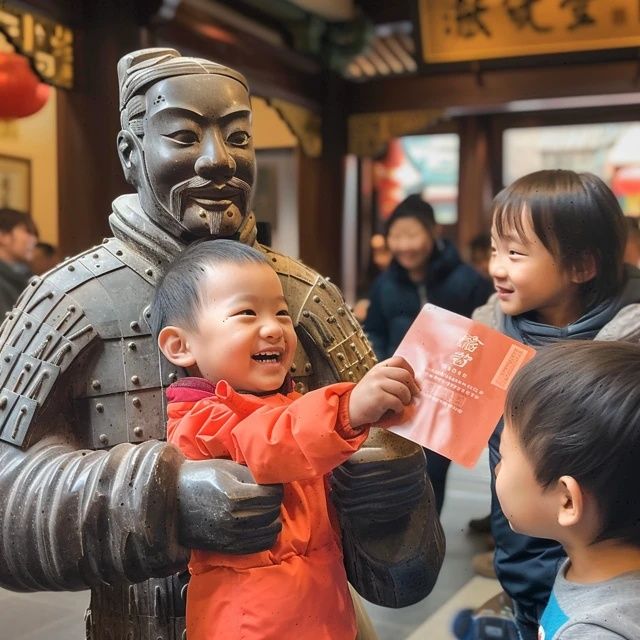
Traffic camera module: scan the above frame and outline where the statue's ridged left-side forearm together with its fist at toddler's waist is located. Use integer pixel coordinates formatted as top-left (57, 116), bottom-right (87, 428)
top-left (0, 437), bottom-right (282, 591)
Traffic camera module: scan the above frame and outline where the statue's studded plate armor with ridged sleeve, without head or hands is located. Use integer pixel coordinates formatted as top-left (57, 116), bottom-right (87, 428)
top-left (0, 199), bottom-right (439, 640)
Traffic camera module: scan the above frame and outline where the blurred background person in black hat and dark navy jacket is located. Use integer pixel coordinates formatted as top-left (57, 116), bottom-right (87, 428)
top-left (364, 194), bottom-right (492, 513)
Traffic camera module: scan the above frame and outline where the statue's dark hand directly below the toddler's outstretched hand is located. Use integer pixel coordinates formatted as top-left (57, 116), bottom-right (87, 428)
top-left (331, 429), bottom-right (427, 524)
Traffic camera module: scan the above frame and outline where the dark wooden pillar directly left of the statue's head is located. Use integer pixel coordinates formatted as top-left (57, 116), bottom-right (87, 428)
top-left (57, 3), bottom-right (143, 255)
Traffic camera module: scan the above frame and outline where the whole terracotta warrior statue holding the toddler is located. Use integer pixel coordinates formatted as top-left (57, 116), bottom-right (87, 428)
top-left (0, 49), bottom-right (444, 640)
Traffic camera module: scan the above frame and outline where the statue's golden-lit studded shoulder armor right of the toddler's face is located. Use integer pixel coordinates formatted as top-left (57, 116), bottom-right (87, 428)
top-left (260, 246), bottom-right (375, 390)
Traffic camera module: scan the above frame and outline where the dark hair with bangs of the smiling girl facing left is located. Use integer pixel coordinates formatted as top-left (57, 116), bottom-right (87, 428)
top-left (492, 169), bottom-right (626, 310)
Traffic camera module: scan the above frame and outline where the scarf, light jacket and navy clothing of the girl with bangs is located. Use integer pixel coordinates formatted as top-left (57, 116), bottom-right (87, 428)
top-left (473, 266), bottom-right (640, 624)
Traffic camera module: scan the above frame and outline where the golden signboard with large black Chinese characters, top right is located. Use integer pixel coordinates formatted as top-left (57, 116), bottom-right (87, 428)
top-left (419, 0), bottom-right (640, 63)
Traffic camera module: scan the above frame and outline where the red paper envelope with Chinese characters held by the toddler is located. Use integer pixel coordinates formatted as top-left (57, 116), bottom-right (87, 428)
top-left (384, 304), bottom-right (535, 467)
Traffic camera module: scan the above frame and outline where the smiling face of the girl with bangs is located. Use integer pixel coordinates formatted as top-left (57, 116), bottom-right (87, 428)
top-left (489, 212), bottom-right (583, 327)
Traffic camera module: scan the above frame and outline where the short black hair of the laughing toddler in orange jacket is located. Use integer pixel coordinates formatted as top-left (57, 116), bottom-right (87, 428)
top-left (149, 239), bottom-right (271, 339)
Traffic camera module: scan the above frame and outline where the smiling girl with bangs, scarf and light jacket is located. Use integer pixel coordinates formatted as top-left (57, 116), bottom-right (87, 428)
top-left (473, 170), bottom-right (640, 640)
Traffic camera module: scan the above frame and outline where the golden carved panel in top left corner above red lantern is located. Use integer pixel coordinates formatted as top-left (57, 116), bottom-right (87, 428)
top-left (0, 3), bottom-right (73, 89)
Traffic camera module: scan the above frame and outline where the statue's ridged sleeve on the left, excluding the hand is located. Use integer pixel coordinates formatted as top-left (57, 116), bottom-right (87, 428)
top-left (0, 438), bottom-right (186, 590)
